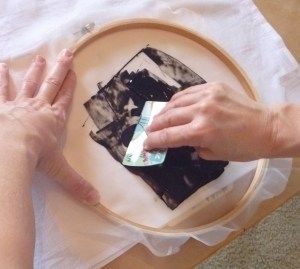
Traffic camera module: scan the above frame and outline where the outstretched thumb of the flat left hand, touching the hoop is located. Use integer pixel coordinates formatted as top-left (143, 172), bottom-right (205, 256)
top-left (39, 152), bottom-right (100, 205)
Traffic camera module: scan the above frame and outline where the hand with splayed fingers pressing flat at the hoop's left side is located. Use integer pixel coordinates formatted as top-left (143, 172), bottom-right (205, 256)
top-left (0, 49), bottom-right (99, 204)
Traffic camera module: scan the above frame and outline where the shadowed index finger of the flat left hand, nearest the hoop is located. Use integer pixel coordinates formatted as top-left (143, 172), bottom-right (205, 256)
top-left (53, 70), bottom-right (76, 113)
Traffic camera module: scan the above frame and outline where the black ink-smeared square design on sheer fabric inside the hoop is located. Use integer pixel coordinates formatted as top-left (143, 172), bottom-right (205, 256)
top-left (84, 47), bottom-right (228, 209)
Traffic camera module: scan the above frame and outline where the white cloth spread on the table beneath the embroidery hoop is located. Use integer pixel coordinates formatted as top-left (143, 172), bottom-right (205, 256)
top-left (0, 0), bottom-right (300, 268)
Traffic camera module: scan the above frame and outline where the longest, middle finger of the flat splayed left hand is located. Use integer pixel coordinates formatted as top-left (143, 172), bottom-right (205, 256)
top-left (37, 49), bottom-right (73, 104)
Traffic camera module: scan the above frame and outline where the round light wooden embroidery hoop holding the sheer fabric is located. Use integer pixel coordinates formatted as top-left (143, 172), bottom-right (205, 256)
top-left (71, 19), bottom-right (269, 237)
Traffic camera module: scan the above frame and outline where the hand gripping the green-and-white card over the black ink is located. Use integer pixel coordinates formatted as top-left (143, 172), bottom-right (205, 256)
top-left (144, 83), bottom-right (276, 161)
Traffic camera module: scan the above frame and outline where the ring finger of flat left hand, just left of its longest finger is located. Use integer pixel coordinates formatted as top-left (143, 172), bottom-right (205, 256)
top-left (17, 55), bottom-right (46, 98)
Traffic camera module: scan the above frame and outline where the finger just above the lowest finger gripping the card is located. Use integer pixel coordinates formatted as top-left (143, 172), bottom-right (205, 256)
top-left (147, 108), bottom-right (193, 133)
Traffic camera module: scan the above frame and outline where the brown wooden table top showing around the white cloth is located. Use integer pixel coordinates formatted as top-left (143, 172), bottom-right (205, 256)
top-left (104, 0), bottom-right (300, 269)
